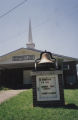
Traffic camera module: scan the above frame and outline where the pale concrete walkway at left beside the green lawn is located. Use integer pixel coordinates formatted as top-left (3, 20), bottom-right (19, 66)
top-left (0, 90), bottom-right (25, 104)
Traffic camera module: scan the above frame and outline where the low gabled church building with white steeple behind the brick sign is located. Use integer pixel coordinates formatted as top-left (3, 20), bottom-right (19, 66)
top-left (0, 21), bottom-right (78, 89)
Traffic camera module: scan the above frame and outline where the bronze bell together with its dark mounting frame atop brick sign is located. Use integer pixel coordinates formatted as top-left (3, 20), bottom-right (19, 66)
top-left (35, 51), bottom-right (56, 71)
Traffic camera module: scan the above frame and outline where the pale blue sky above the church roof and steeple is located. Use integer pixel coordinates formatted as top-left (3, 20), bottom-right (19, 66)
top-left (0, 0), bottom-right (78, 58)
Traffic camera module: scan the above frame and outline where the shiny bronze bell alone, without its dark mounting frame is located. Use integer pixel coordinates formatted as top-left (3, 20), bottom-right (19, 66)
top-left (38, 52), bottom-right (54, 64)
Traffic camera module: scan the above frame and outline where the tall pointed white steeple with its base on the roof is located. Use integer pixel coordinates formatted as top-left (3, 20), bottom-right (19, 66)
top-left (26, 20), bottom-right (35, 49)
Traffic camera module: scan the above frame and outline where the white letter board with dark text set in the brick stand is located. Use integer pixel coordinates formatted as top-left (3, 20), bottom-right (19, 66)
top-left (36, 75), bottom-right (60, 101)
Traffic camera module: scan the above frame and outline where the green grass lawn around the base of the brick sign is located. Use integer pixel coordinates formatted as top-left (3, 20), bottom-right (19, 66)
top-left (0, 89), bottom-right (78, 120)
